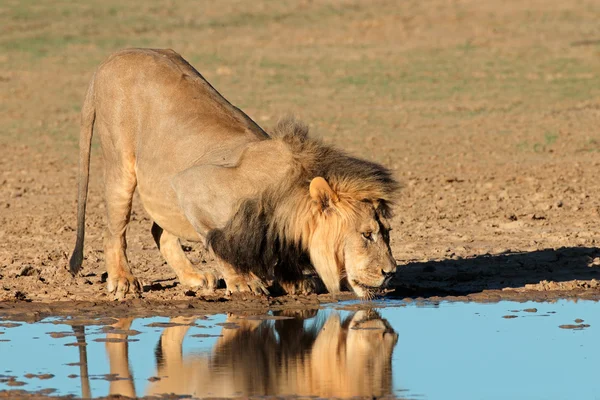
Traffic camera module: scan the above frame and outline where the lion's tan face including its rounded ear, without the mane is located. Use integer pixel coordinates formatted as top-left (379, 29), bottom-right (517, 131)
top-left (310, 178), bottom-right (396, 297)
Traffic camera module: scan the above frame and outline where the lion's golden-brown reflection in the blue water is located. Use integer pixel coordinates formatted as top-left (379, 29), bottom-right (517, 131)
top-left (106, 310), bottom-right (397, 397)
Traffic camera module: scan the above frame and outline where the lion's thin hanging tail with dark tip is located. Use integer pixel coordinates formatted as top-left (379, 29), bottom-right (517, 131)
top-left (69, 76), bottom-right (96, 276)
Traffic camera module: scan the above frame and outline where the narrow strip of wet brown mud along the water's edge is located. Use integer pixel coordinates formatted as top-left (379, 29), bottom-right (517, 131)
top-left (0, 288), bottom-right (600, 325)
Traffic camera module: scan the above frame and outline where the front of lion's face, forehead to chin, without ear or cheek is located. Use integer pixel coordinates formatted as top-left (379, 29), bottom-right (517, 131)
top-left (343, 202), bottom-right (396, 297)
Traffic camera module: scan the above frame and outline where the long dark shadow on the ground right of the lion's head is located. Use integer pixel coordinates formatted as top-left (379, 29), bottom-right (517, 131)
top-left (391, 247), bottom-right (600, 297)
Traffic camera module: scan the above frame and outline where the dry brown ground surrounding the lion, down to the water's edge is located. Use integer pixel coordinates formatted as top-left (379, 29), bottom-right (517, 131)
top-left (0, 0), bottom-right (600, 318)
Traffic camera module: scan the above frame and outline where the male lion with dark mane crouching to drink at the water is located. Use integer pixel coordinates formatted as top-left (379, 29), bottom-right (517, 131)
top-left (70, 49), bottom-right (398, 297)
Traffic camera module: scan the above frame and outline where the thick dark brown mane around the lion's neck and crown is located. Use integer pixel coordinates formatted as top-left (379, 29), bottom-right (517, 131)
top-left (207, 119), bottom-right (399, 281)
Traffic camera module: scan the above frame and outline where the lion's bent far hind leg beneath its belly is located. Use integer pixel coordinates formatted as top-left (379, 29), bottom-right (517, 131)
top-left (152, 223), bottom-right (219, 290)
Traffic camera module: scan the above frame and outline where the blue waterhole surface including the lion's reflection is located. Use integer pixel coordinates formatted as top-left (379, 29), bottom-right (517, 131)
top-left (0, 301), bottom-right (600, 400)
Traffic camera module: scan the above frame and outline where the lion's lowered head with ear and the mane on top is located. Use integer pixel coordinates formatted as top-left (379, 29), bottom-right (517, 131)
top-left (284, 120), bottom-right (399, 297)
